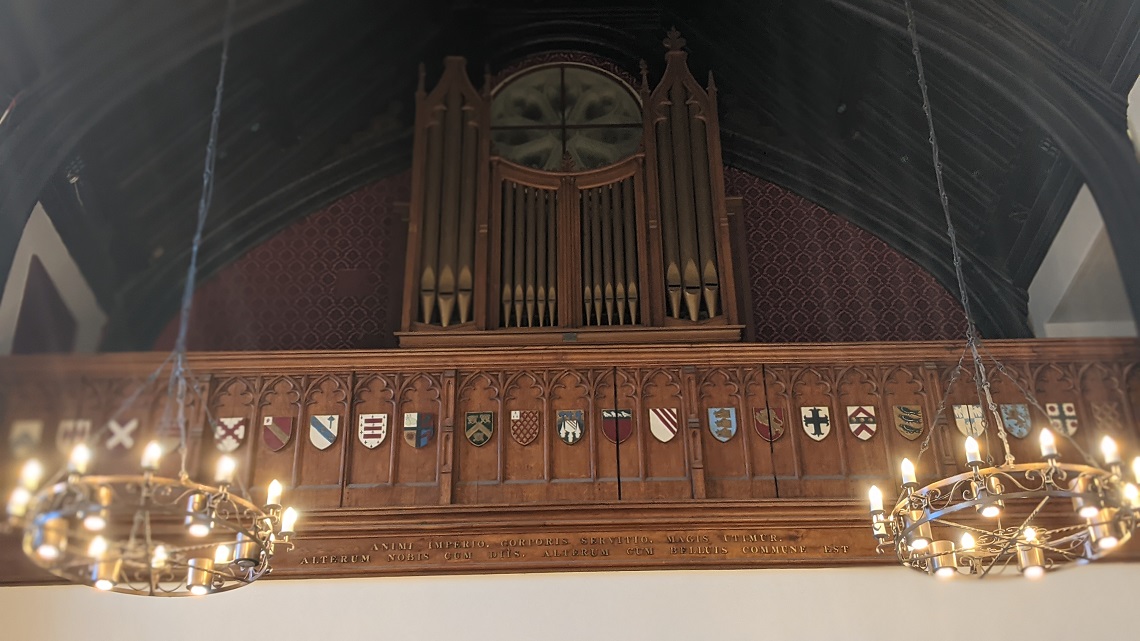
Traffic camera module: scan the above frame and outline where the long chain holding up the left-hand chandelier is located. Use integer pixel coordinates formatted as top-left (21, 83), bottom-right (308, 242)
top-left (168, 0), bottom-right (235, 478)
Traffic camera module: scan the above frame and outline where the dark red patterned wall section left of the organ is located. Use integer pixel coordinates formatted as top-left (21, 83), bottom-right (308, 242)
top-left (155, 173), bottom-right (410, 350)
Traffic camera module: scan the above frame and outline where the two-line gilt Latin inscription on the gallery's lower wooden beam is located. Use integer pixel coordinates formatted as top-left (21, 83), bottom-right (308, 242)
top-left (285, 530), bottom-right (865, 570)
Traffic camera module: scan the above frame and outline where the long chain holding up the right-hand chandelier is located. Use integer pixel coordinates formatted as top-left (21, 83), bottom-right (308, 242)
top-left (903, 0), bottom-right (1013, 465)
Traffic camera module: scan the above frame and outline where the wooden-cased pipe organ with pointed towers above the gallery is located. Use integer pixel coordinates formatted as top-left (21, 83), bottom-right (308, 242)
top-left (399, 31), bottom-right (741, 347)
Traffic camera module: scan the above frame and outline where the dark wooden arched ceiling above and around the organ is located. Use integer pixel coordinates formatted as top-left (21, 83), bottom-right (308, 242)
top-left (0, 0), bottom-right (1140, 349)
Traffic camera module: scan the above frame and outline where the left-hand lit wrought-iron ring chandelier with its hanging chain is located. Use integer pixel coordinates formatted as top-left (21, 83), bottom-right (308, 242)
top-left (7, 0), bottom-right (298, 597)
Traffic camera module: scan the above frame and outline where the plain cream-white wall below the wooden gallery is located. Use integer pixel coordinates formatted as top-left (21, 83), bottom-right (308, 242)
top-left (0, 563), bottom-right (1140, 641)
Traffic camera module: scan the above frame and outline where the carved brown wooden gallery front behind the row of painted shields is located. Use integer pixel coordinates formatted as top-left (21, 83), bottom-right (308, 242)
top-left (0, 340), bottom-right (1140, 574)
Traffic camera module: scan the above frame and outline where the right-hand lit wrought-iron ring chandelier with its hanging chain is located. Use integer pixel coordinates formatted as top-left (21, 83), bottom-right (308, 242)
top-left (870, 0), bottom-right (1140, 578)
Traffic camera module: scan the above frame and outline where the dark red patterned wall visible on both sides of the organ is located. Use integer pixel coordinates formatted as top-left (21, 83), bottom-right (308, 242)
top-left (155, 164), bottom-right (964, 350)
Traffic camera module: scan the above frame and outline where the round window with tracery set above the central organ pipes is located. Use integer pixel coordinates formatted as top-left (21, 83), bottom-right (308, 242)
top-left (491, 64), bottom-right (642, 171)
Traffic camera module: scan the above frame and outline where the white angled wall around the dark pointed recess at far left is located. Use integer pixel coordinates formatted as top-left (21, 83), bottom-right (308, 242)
top-left (0, 204), bottom-right (107, 356)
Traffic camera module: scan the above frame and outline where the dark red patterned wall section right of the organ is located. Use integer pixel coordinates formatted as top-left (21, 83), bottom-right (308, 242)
top-left (725, 168), bottom-right (966, 342)
